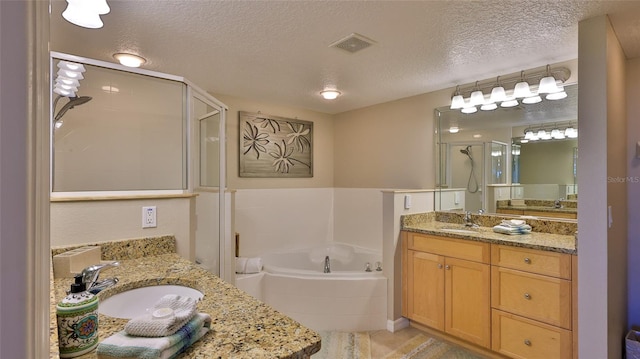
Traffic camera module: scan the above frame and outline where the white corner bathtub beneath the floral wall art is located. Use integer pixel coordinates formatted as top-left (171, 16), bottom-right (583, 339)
top-left (236, 243), bottom-right (387, 331)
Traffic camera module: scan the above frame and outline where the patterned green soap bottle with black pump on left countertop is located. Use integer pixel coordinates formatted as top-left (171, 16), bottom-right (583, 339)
top-left (56, 274), bottom-right (98, 358)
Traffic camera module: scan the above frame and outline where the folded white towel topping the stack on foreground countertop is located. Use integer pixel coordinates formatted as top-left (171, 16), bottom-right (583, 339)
top-left (124, 294), bottom-right (196, 337)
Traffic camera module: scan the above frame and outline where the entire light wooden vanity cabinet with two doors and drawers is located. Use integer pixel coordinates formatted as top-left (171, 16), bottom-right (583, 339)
top-left (402, 231), bottom-right (578, 359)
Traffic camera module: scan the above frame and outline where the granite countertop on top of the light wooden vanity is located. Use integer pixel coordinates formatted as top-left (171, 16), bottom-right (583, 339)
top-left (401, 215), bottom-right (578, 254)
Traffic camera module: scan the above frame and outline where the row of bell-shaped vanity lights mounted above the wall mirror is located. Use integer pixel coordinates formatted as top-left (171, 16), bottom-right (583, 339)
top-left (450, 65), bottom-right (571, 113)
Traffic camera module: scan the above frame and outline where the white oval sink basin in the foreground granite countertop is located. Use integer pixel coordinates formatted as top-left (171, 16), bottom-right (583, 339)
top-left (98, 285), bottom-right (204, 319)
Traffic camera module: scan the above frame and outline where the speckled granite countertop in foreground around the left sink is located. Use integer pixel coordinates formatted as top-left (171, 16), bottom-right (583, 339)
top-left (51, 253), bottom-right (320, 359)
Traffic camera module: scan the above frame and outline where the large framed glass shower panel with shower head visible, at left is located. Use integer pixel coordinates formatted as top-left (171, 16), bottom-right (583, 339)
top-left (51, 54), bottom-right (188, 193)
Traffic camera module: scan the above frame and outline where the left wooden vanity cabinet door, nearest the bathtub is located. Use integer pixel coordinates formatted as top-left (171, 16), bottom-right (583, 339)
top-left (407, 250), bottom-right (444, 330)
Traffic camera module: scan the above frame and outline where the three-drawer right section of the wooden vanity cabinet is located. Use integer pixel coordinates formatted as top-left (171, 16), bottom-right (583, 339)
top-left (491, 244), bottom-right (577, 358)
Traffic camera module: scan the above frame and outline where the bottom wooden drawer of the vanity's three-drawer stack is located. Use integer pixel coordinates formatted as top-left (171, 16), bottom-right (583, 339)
top-left (491, 309), bottom-right (573, 359)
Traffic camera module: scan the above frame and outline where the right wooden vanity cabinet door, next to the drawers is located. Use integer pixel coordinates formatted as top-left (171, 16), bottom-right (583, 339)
top-left (445, 258), bottom-right (491, 348)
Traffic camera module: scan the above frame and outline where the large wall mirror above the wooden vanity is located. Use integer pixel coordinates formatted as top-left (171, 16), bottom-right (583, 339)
top-left (435, 84), bottom-right (578, 218)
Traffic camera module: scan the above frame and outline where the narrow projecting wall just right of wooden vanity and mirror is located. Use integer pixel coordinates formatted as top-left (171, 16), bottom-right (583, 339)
top-left (578, 16), bottom-right (627, 358)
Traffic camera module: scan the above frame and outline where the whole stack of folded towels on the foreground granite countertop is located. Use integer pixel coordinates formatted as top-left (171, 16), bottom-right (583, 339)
top-left (96, 294), bottom-right (211, 359)
